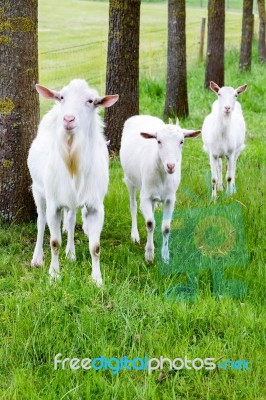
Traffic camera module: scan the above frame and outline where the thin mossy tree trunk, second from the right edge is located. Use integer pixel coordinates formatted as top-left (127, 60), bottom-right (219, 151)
top-left (239, 0), bottom-right (254, 71)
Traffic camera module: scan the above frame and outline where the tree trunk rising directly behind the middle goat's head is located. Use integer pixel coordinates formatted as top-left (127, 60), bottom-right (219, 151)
top-left (164, 0), bottom-right (188, 117)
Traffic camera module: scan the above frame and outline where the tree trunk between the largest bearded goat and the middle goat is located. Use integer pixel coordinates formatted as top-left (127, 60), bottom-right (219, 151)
top-left (105, 0), bottom-right (141, 153)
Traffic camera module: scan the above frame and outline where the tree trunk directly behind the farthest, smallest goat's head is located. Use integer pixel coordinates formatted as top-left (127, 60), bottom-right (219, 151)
top-left (205, 0), bottom-right (225, 88)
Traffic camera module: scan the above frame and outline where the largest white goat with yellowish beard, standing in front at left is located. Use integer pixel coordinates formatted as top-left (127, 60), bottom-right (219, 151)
top-left (28, 79), bottom-right (118, 285)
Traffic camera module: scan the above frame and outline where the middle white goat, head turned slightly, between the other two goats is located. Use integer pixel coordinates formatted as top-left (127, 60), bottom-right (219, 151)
top-left (120, 115), bottom-right (200, 262)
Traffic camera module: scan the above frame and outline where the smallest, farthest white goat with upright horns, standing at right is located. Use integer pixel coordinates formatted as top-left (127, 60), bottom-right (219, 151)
top-left (202, 82), bottom-right (247, 199)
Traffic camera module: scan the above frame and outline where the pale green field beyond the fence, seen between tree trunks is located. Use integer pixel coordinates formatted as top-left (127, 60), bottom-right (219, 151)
top-left (39, 0), bottom-right (257, 111)
